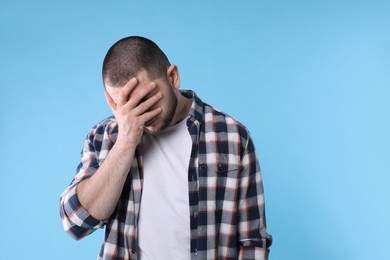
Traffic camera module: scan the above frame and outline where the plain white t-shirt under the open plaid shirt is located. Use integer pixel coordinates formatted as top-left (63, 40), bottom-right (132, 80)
top-left (138, 119), bottom-right (192, 260)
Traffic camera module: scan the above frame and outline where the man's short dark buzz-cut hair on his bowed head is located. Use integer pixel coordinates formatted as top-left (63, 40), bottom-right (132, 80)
top-left (102, 36), bottom-right (171, 87)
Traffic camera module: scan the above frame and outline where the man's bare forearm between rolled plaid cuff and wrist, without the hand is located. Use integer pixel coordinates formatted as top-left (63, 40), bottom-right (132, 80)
top-left (77, 142), bottom-right (136, 220)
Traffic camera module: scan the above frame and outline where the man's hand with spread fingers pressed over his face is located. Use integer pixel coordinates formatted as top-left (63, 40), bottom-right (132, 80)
top-left (104, 78), bottom-right (162, 147)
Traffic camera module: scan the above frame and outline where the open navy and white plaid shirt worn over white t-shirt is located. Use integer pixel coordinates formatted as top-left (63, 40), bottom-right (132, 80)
top-left (60, 91), bottom-right (272, 259)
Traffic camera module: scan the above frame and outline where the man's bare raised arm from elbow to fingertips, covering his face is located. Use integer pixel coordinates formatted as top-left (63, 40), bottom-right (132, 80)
top-left (77, 78), bottom-right (162, 220)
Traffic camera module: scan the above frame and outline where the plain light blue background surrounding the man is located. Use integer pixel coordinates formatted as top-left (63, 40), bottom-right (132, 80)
top-left (0, 0), bottom-right (390, 260)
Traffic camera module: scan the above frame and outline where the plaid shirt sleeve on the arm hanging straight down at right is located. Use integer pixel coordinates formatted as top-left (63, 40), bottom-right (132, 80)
top-left (238, 131), bottom-right (272, 260)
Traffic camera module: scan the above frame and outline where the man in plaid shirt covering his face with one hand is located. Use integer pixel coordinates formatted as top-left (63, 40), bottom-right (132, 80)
top-left (61, 36), bottom-right (272, 260)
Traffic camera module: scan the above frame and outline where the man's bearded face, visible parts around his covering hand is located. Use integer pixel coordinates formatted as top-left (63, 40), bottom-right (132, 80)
top-left (106, 71), bottom-right (177, 134)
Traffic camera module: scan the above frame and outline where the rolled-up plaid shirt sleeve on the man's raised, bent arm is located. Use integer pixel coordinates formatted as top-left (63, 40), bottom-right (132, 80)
top-left (60, 125), bottom-right (110, 240)
